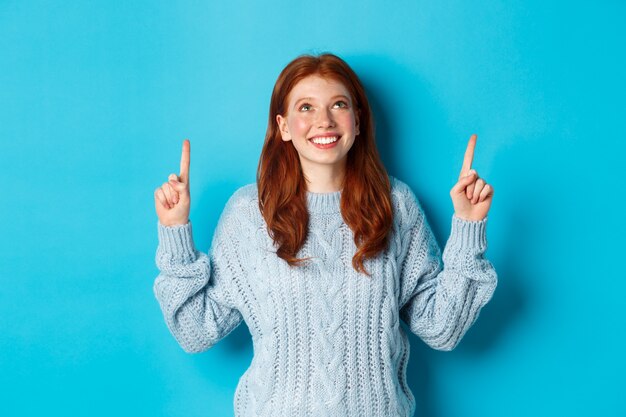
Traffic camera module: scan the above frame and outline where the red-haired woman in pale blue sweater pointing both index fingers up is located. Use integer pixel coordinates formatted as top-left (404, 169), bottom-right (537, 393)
top-left (154, 54), bottom-right (497, 417)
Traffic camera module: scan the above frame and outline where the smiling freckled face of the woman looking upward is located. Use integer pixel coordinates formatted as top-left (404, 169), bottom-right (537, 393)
top-left (276, 75), bottom-right (359, 174)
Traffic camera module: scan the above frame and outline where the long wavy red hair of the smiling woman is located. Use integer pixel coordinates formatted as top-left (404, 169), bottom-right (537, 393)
top-left (257, 53), bottom-right (392, 276)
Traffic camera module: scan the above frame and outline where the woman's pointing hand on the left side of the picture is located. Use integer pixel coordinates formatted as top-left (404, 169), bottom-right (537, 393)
top-left (154, 139), bottom-right (191, 226)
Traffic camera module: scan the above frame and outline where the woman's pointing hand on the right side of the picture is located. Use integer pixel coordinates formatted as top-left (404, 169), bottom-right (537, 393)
top-left (450, 134), bottom-right (493, 220)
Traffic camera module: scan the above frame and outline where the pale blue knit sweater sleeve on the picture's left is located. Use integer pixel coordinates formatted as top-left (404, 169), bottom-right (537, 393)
top-left (153, 193), bottom-right (243, 353)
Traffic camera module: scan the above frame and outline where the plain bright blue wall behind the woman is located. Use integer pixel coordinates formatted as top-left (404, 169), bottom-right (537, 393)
top-left (0, 0), bottom-right (626, 417)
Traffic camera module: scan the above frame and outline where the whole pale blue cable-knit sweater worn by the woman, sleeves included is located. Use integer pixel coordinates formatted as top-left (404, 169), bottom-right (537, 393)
top-left (154, 176), bottom-right (497, 417)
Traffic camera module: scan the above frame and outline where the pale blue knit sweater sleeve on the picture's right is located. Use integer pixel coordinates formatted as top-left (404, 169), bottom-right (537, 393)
top-left (399, 187), bottom-right (497, 351)
